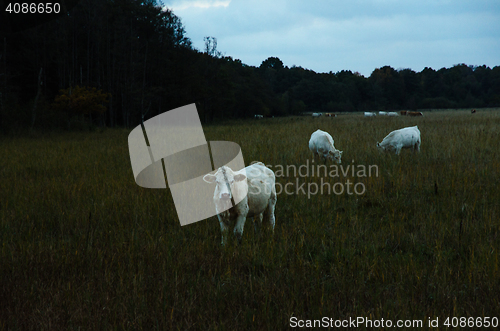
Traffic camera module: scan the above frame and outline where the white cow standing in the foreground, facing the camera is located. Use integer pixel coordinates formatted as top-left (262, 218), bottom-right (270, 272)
top-left (203, 162), bottom-right (277, 245)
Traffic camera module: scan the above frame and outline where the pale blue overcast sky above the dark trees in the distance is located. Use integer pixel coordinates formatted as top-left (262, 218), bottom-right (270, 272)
top-left (163, 0), bottom-right (500, 77)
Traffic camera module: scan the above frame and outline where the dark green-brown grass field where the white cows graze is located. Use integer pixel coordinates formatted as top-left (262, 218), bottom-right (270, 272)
top-left (0, 110), bottom-right (500, 330)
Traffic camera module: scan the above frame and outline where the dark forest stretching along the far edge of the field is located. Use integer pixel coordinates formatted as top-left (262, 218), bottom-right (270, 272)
top-left (0, 0), bottom-right (500, 132)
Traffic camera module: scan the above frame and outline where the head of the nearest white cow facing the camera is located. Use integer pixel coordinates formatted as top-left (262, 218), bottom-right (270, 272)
top-left (203, 166), bottom-right (247, 203)
